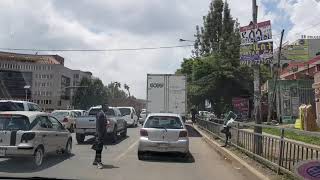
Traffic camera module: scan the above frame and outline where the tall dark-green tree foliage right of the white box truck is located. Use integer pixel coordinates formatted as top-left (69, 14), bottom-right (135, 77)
top-left (176, 0), bottom-right (270, 115)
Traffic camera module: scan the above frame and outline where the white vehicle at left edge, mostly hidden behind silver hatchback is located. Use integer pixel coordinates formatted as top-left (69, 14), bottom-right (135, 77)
top-left (0, 100), bottom-right (41, 111)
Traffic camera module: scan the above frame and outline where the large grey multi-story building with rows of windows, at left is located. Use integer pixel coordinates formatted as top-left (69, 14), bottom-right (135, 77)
top-left (0, 52), bottom-right (92, 110)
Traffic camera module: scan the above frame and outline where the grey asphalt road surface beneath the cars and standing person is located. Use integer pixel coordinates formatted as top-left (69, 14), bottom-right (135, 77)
top-left (0, 127), bottom-right (252, 180)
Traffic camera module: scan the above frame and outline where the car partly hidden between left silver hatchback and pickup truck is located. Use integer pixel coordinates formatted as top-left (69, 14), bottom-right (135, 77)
top-left (51, 110), bottom-right (77, 133)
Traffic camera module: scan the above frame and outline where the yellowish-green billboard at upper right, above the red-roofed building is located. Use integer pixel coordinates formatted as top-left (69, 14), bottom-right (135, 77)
top-left (283, 39), bottom-right (310, 61)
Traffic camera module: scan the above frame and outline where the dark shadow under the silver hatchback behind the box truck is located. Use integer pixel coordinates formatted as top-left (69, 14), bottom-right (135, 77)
top-left (143, 153), bottom-right (195, 163)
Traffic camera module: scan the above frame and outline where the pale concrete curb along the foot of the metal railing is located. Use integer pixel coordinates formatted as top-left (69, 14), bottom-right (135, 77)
top-left (192, 125), bottom-right (270, 180)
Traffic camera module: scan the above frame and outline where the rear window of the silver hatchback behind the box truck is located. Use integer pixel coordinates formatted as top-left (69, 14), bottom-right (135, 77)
top-left (144, 116), bottom-right (183, 129)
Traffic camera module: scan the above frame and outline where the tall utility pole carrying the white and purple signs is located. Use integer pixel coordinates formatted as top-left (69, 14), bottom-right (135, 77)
top-left (252, 0), bottom-right (262, 155)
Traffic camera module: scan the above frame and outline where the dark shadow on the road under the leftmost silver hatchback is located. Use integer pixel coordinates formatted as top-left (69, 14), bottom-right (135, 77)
top-left (0, 154), bottom-right (74, 173)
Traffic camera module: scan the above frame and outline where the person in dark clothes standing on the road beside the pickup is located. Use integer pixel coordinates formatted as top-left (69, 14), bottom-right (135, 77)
top-left (93, 104), bottom-right (109, 169)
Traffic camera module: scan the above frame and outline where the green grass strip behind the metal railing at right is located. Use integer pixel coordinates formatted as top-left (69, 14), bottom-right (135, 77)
top-left (263, 128), bottom-right (320, 146)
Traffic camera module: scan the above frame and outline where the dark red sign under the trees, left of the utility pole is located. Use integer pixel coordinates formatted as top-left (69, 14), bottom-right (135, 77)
top-left (232, 98), bottom-right (249, 118)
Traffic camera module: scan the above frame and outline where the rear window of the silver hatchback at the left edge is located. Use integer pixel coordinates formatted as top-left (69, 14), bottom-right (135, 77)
top-left (0, 115), bottom-right (30, 130)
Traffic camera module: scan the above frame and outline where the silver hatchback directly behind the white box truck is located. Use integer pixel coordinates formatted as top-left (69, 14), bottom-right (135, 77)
top-left (138, 113), bottom-right (189, 159)
